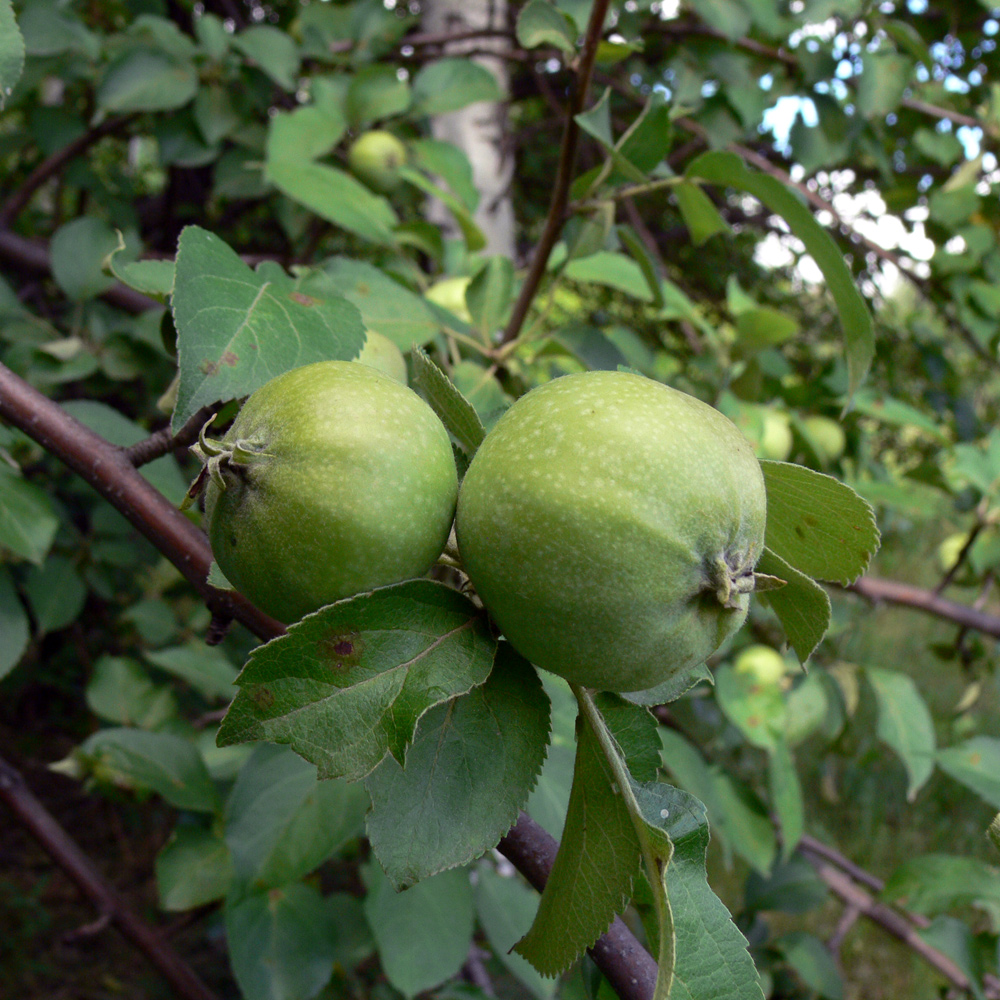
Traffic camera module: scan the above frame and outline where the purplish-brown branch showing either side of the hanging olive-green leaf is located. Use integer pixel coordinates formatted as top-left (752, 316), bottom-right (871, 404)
top-left (497, 813), bottom-right (657, 1000)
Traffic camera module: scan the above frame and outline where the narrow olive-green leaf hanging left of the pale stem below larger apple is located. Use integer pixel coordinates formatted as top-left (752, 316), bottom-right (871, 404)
top-left (514, 708), bottom-right (641, 976)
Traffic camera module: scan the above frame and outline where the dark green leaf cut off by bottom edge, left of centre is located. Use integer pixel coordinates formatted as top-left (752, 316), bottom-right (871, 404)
top-left (223, 883), bottom-right (340, 1000)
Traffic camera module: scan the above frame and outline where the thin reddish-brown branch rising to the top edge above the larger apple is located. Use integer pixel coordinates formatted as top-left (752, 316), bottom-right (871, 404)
top-left (500, 0), bottom-right (609, 344)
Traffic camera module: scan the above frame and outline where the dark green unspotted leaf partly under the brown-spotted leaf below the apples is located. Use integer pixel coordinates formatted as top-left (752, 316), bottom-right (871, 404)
top-left (365, 643), bottom-right (549, 892)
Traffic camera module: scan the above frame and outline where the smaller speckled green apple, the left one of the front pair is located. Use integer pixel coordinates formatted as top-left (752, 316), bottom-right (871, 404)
top-left (205, 361), bottom-right (458, 622)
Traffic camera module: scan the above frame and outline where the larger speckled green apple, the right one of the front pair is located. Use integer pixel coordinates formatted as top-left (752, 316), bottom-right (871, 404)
top-left (456, 371), bottom-right (766, 692)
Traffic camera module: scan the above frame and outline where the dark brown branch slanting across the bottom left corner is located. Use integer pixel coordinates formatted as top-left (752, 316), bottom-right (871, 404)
top-left (0, 757), bottom-right (217, 1000)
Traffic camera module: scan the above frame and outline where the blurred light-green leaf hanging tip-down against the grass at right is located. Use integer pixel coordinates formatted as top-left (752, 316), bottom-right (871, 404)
top-left (866, 667), bottom-right (935, 802)
